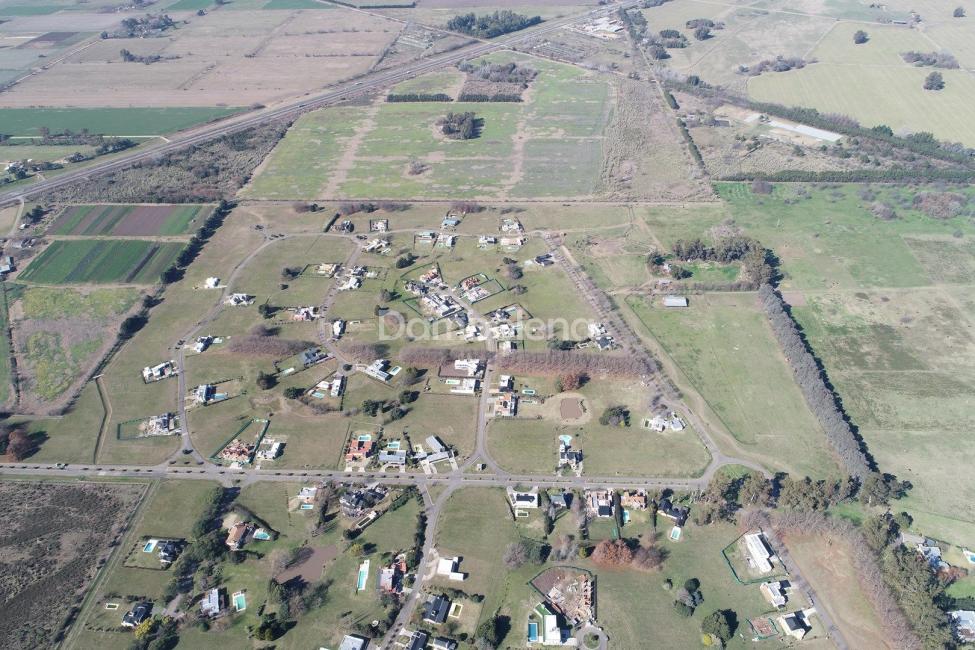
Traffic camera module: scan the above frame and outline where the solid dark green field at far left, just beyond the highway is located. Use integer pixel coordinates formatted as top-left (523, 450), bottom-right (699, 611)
top-left (0, 107), bottom-right (242, 136)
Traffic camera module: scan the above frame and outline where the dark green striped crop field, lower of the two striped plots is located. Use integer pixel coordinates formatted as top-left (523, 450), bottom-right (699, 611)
top-left (20, 239), bottom-right (183, 284)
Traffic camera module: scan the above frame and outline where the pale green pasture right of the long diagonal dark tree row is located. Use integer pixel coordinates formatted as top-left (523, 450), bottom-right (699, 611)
top-left (794, 287), bottom-right (975, 544)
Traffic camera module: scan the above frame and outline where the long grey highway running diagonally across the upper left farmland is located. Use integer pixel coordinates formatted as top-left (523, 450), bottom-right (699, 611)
top-left (0, 0), bottom-right (638, 206)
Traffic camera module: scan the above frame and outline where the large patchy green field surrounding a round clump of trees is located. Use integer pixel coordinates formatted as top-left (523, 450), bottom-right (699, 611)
top-left (252, 53), bottom-right (612, 199)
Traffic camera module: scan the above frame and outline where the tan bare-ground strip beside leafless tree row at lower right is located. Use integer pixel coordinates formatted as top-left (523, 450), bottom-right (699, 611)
top-left (784, 535), bottom-right (893, 648)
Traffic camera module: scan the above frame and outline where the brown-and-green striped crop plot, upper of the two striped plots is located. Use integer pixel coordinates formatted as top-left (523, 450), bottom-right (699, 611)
top-left (50, 204), bottom-right (212, 236)
